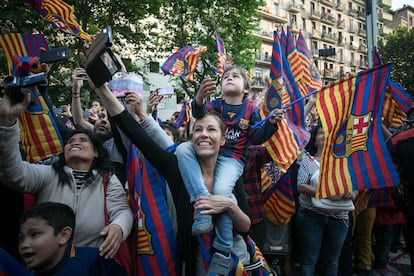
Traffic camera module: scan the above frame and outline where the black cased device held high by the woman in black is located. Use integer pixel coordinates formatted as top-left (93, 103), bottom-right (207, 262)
top-left (85, 26), bottom-right (121, 87)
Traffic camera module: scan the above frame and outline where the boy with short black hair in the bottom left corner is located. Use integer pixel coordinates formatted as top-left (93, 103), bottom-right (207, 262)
top-left (19, 202), bottom-right (127, 276)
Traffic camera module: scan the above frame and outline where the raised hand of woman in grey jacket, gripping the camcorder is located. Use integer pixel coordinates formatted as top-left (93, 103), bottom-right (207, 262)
top-left (0, 93), bottom-right (31, 126)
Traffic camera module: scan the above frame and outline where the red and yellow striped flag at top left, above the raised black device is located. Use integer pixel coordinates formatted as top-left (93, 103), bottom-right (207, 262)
top-left (25, 0), bottom-right (91, 41)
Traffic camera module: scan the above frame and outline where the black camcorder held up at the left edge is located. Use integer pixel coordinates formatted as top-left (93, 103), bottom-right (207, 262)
top-left (3, 72), bottom-right (47, 103)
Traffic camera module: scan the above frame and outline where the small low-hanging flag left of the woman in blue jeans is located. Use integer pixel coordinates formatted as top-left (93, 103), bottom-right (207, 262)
top-left (263, 170), bottom-right (296, 225)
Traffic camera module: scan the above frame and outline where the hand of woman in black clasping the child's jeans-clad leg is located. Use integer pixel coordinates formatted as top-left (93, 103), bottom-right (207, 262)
top-left (194, 195), bottom-right (234, 215)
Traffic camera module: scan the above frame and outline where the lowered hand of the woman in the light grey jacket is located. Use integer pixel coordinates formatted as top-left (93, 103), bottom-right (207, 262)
top-left (99, 224), bottom-right (122, 259)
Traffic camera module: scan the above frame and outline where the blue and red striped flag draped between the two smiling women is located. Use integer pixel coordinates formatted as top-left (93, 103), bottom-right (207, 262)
top-left (127, 144), bottom-right (181, 275)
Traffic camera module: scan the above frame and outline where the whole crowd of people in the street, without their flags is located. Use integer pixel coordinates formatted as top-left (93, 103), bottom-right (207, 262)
top-left (0, 53), bottom-right (414, 276)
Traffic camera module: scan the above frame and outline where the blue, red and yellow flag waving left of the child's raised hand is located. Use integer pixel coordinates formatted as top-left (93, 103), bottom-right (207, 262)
top-left (161, 45), bottom-right (207, 82)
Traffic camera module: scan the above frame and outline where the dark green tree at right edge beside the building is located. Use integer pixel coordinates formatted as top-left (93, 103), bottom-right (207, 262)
top-left (378, 26), bottom-right (414, 96)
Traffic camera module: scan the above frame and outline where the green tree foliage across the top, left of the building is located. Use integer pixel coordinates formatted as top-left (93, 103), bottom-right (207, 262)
top-left (0, 0), bottom-right (262, 105)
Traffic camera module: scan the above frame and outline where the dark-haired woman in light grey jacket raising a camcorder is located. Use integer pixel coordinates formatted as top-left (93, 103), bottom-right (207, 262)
top-left (0, 94), bottom-right (133, 258)
